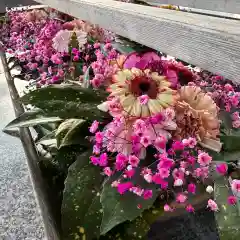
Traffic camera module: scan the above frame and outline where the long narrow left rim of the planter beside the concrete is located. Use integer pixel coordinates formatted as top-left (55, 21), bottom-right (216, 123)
top-left (0, 49), bottom-right (60, 240)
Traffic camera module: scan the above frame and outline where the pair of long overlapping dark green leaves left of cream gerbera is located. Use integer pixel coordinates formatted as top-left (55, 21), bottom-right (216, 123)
top-left (21, 84), bottom-right (107, 120)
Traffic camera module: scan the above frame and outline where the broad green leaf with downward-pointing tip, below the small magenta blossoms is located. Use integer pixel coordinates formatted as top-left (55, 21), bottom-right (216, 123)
top-left (101, 175), bottom-right (157, 235)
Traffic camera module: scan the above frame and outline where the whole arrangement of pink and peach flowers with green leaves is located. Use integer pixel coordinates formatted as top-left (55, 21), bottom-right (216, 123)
top-left (1, 6), bottom-right (240, 239)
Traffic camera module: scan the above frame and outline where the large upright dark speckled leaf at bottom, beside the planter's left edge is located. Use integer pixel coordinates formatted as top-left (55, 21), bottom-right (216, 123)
top-left (62, 152), bottom-right (102, 240)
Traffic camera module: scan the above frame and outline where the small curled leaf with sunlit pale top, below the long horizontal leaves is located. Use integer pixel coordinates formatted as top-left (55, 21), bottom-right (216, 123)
top-left (56, 119), bottom-right (90, 148)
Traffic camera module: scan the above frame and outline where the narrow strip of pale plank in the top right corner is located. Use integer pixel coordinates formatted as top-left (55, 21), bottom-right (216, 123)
top-left (142, 0), bottom-right (240, 14)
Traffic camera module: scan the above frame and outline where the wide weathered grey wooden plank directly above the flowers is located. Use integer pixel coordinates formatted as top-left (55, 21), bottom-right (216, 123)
top-left (37, 0), bottom-right (240, 82)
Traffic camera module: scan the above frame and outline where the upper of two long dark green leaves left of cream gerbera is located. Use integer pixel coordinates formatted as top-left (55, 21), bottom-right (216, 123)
top-left (21, 84), bottom-right (107, 106)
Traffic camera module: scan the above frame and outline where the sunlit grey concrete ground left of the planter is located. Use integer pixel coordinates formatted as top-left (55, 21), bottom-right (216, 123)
top-left (0, 58), bottom-right (44, 240)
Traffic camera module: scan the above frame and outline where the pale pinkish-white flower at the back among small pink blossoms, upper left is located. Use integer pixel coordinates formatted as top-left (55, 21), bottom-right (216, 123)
top-left (53, 30), bottom-right (87, 52)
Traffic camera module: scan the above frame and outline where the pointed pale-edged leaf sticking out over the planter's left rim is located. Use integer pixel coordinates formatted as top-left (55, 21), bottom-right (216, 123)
top-left (4, 110), bottom-right (61, 130)
